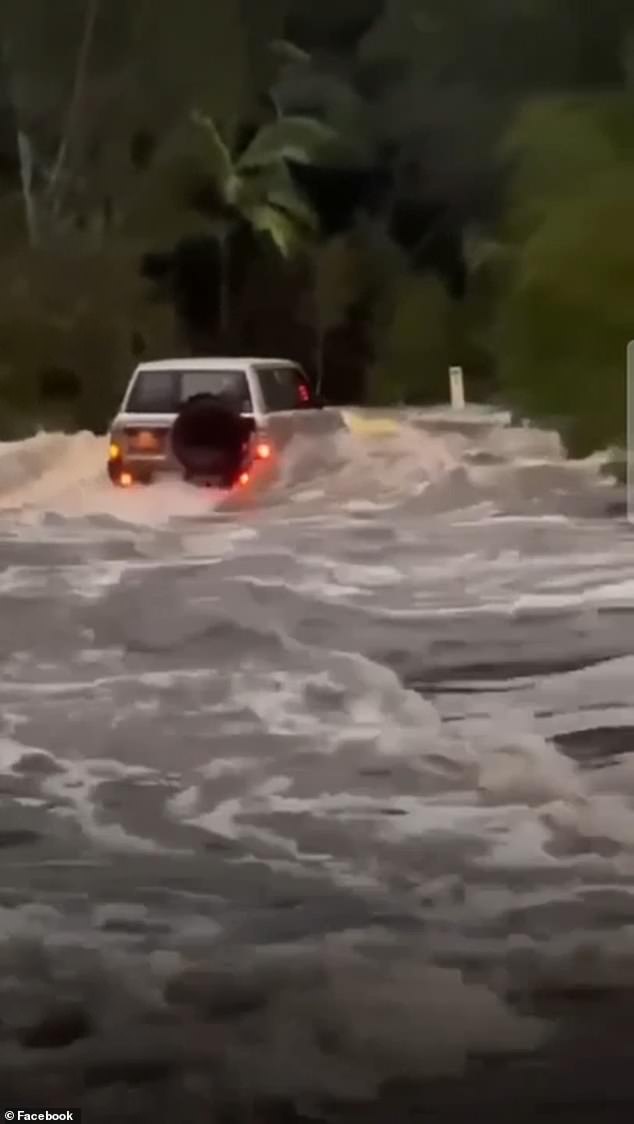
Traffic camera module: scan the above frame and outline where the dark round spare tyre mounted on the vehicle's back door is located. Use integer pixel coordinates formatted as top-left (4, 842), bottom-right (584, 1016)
top-left (172, 395), bottom-right (246, 486)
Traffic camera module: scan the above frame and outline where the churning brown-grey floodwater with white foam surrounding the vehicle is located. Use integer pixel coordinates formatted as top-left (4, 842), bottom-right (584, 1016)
top-left (0, 415), bottom-right (634, 1124)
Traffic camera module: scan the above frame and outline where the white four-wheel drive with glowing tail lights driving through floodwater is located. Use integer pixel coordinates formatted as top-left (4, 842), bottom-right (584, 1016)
top-left (108, 359), bottom-right (344, 488)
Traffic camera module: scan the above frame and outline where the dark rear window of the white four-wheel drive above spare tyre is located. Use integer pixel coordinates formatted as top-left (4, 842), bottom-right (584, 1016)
top-left (126, 369), bottom-right (253, 414)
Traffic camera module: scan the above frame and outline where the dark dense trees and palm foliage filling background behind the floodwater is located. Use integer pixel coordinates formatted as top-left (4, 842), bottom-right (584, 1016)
top-left (0, 0), bottom-right (634, 452)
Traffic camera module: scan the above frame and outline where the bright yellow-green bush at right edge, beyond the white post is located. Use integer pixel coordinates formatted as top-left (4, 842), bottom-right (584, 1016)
top-left (499, 164), bottom-right (634, 454)
